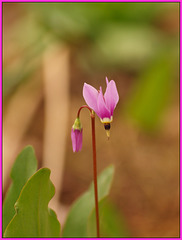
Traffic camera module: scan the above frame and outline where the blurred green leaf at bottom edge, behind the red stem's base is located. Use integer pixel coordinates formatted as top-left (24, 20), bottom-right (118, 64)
top-left (87, 199), bottom-right (129, 237)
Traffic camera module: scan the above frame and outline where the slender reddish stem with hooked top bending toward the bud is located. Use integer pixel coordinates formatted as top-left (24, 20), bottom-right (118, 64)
top-left (77, 105), bottom-right (100, 238)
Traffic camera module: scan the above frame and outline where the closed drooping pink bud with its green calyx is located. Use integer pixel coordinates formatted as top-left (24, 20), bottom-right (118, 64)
top-left (71, 118), bottom-right (83, 152)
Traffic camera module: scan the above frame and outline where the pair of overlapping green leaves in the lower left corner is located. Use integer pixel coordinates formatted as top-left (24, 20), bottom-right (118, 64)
top-left (3, 146), bottom-right (60, 237)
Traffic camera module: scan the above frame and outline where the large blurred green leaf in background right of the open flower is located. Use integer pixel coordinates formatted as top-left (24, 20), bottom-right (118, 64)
top-left (125, 46), bottom-right (178, 131)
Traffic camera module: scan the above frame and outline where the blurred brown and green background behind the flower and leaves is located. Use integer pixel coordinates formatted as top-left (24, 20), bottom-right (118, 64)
top-left (3, 3), bottom-right (179, 237)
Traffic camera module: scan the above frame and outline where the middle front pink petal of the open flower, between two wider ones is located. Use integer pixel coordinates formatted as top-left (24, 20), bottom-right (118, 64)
top-left (97, 87), bottom-right (111, 119)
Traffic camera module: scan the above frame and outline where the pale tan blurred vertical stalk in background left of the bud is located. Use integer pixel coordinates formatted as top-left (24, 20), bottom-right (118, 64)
top-left (43, 44), bottom-right (70, 222)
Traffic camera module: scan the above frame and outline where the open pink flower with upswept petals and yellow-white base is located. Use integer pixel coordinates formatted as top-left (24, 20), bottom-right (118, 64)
top-left (83, 77), bottom-right (119, 124)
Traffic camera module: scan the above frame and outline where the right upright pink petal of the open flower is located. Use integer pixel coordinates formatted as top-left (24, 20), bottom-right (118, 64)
top-left (104, 80), bottom-right (119, 116)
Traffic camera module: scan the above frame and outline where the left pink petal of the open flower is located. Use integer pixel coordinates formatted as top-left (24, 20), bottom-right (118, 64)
top-left (83, 83), bottom-right (99, 113)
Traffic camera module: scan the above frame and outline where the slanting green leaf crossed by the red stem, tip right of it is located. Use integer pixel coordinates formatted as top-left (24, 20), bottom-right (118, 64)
top-left (63, 165), bottom-right (114, 237)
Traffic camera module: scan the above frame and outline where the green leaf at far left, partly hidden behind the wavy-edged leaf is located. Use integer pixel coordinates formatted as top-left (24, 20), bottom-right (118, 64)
top-left (3, 146), bottom-right (37, 233)
